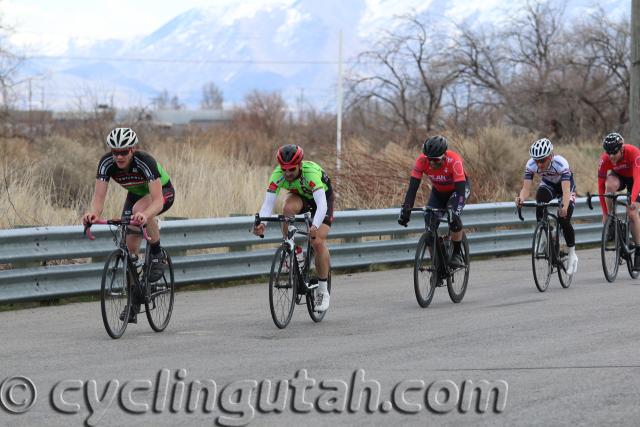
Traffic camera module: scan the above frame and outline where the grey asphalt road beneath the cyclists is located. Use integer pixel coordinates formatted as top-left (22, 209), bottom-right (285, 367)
top-left (0, 250), bottom-right (640, 426)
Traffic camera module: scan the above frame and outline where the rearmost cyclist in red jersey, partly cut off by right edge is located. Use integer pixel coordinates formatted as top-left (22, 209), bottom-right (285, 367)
top-left (598, 132), bottom-right (640, 266)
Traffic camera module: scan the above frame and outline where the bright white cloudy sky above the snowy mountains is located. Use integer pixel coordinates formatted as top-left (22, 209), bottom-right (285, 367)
top-left (0, 0), bottom-right (631, 53)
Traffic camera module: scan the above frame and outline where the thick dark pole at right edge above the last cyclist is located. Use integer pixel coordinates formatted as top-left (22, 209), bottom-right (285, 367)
top-left (628, 0), bottom-right (640, 146)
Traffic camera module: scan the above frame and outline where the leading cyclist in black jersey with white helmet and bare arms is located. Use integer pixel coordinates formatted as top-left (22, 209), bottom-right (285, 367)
top-left (82, 128), bottom-right (175, 322)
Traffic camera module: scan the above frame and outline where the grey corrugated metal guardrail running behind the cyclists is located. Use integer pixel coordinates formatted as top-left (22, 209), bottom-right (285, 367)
top-left (0, 198), bottom-right (602, 302)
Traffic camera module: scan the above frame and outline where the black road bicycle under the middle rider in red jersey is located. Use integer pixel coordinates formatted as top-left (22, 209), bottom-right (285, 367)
top-left (404, 206), bottom-right (469, 308)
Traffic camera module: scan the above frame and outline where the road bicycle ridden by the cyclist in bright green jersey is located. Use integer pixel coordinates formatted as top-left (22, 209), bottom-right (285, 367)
top-left (254, 212), bottom-right (331, 329)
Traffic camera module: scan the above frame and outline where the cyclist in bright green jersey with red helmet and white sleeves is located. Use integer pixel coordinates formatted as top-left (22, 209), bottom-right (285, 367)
top-left (253, 145), bottom-right (334, 312)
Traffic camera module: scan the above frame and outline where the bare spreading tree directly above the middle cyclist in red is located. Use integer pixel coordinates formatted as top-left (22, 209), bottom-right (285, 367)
top-left (348, 15), bottom-right (459, 142)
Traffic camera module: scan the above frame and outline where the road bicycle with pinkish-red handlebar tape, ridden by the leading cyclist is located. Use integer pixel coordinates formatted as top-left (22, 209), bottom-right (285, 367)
top-left (84, 217), bottom-right (175, 339)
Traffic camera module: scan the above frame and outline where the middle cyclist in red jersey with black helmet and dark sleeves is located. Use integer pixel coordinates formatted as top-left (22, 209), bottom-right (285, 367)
top-left (398, 135), bottom-right (470, 268)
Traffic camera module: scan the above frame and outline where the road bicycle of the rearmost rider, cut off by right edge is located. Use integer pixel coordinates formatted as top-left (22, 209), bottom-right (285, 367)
top-left (587, 193), bottom-right (640, 282)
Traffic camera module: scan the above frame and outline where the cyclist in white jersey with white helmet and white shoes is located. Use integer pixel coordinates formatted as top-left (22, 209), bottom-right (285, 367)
top-left (516, 138), bottom-right (578, 275)
